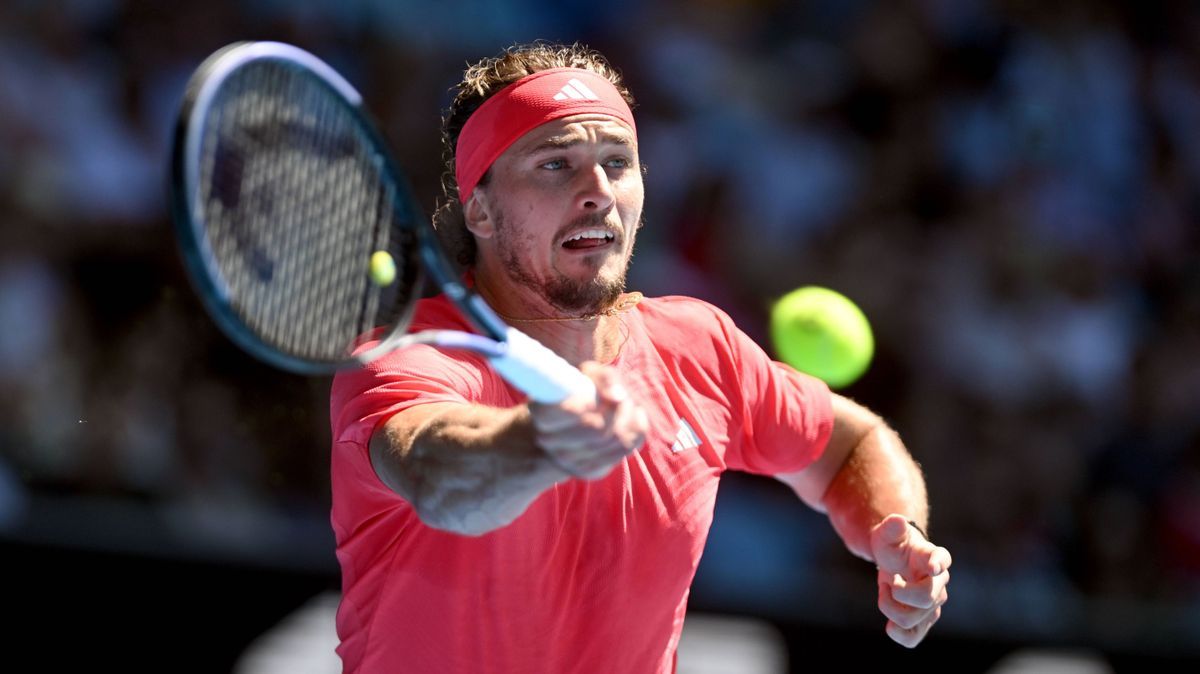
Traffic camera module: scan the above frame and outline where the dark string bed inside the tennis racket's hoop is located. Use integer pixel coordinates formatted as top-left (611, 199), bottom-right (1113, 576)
top-left (198, 61), bottom-right (413, 361)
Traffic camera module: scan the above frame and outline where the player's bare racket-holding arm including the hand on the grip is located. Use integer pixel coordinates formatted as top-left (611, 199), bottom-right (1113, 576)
top-left (370, 363), bottom-right (647, 536)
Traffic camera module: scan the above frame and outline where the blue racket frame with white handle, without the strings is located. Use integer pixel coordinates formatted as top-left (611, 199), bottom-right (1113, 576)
top-left (170, 42), bottom-right (595, 403)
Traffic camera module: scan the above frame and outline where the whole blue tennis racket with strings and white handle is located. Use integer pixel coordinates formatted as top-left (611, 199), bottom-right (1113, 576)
top-left (172, 42), bottom-right (595, 403)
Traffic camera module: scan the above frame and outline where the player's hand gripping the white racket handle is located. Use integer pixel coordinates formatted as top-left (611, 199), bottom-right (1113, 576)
top-left (529, 362), bottom-right (649, 480)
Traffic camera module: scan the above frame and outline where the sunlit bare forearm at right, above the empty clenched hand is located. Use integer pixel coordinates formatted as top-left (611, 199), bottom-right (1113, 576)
top-left (822, 421), bottom-right (929, 560)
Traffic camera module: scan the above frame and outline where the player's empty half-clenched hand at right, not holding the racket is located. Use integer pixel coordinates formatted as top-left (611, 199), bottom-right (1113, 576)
top-left (871, 514), bottom-right (950, 648)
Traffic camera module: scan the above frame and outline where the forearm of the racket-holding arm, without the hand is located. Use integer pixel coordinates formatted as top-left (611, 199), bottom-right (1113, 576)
top-left (371, 404), bottom-right (566, 535)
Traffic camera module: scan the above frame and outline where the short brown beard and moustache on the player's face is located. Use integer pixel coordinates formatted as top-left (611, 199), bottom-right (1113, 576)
top-left (496, 213), bottom-right (641, 315)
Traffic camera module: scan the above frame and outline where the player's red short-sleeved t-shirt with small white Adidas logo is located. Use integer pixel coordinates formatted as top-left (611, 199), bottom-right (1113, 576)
top-left (331, 297), bottom-right (833, 674)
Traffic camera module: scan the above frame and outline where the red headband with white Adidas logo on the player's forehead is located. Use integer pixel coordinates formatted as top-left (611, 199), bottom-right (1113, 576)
top-left (455, 68), bottom-right (637, 203)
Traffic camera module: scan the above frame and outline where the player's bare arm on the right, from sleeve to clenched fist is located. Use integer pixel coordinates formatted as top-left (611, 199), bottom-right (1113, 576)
top-left (778, 395), bottom-right (950, 648)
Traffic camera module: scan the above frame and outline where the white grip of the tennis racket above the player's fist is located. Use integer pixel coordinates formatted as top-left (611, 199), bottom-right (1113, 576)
top-left (488, 327), bottom-right (596, 403)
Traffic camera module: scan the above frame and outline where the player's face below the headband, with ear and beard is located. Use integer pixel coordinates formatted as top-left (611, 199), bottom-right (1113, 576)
top-left (468, 115), bottom-right (644, 313)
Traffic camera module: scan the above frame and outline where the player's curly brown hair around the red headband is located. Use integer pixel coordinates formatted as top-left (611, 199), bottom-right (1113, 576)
top-left (433, 42), bottom-right (634, 267)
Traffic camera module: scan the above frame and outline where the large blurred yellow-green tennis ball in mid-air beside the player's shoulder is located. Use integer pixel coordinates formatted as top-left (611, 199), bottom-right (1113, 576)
top-left (770, 285), bottom-right (875, 389)
